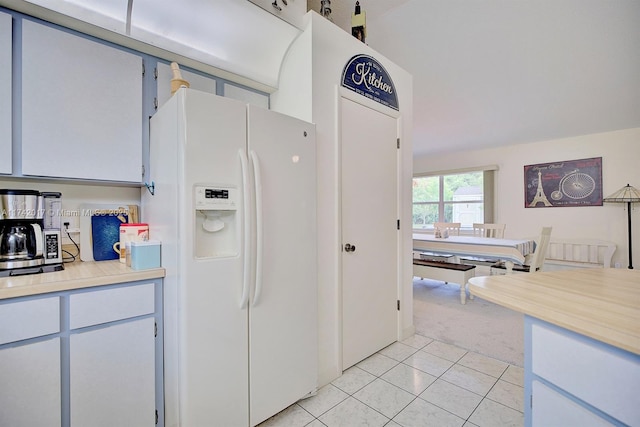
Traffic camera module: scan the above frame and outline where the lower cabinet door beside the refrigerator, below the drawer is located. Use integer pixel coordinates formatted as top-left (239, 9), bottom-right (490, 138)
top-left (69, 318), bottom-right (156, 427)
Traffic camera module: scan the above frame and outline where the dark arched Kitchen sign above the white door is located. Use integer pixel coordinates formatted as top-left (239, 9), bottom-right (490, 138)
top-left (341, 55), bottom-right (398, 110)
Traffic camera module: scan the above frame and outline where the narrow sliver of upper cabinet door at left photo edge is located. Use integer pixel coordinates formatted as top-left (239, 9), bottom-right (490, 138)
top-left (0, 12), bottom-right (12, 174)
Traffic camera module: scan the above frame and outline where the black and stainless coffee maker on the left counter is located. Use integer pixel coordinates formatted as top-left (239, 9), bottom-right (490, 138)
top-left (0, 189), bottom-right (63, 277)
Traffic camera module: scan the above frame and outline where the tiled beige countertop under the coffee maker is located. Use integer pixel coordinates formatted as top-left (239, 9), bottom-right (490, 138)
top-left (0, 260), bottom-right (165, 300)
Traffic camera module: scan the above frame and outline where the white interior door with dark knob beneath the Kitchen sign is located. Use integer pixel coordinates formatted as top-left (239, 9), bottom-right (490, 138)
top-left (341, 98), bottom-right (398, 369)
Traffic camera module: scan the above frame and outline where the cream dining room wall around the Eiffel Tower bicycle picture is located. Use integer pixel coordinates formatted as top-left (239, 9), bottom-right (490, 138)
top-left (414, 128), bottom-right (640, 268)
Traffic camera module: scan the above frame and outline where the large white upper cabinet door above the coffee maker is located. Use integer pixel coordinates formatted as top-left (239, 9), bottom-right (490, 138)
top-left (21, 20), bottom-right (143, 183)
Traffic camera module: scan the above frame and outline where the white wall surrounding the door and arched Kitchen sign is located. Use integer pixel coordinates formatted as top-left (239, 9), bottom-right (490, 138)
top-left (271, 12), bottom-right (413, 385)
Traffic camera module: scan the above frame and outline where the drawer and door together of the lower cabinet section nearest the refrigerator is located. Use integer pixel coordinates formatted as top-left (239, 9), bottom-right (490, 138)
top-left (69, 282), bottom-right (157, 427)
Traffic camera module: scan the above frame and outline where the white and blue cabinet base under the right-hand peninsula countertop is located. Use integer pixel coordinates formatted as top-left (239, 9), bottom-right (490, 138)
top-left (525, 316), bottom-right (640, 427)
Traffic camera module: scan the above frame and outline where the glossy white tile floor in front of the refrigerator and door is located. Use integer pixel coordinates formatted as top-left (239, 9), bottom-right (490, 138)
top-left (259, 335), bottom-right (524, 427)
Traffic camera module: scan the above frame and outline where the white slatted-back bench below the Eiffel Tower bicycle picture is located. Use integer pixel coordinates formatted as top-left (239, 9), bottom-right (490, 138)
top-left (543, 238), bottom-right (616, 271)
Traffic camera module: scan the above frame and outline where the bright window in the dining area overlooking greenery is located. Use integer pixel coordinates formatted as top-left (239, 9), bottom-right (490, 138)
top-left (413, 170), bottom-right (493, 230)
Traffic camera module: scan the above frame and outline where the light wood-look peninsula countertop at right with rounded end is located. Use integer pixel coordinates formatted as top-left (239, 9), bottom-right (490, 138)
top-left (469, 268), bottom-right (640, 354)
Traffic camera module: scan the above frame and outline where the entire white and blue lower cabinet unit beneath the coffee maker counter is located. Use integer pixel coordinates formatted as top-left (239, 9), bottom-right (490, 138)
top-left (0, 279), bottom-right (164, 427)
